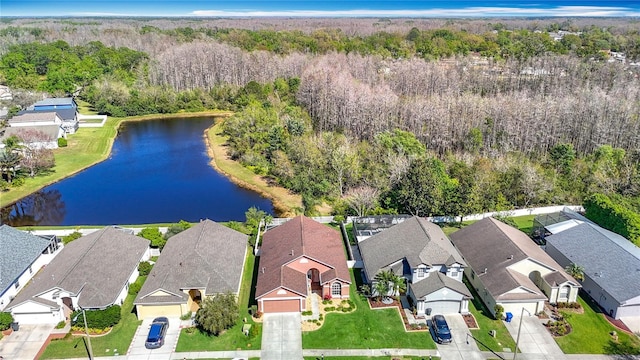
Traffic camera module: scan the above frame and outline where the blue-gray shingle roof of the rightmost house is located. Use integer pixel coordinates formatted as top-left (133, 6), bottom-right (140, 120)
top-left (546, 223), bottom-right (640, 303)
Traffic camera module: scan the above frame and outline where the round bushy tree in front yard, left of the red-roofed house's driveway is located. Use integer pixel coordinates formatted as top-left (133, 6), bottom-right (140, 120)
top-left (196, 292), bottom-right (240, 336)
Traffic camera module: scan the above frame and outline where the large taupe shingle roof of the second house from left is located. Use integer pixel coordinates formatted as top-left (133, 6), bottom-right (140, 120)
top-left (9, 227), bottom-right (149, 308)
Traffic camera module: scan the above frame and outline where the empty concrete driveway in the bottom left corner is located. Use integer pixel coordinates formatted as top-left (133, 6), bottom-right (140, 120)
top-left (0, 325), bottom-right (54, 360)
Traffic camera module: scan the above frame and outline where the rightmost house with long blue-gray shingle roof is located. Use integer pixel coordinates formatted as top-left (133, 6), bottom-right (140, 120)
top-left (545, 222), bottom-right (640, 319)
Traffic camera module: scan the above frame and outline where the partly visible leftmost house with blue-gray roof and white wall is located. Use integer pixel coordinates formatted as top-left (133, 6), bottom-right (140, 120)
top-left (0, 225), bottom-right (62, 311)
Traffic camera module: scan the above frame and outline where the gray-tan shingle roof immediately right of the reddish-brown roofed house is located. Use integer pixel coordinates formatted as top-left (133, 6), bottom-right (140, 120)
top-left (358, 217), bottom-right (466, 276)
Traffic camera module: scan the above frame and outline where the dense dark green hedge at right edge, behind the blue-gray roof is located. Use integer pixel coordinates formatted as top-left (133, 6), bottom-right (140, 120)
top-left (584, 193), bottom-right (640, 245)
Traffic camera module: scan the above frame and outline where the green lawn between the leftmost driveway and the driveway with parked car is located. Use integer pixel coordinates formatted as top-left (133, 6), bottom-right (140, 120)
top-left (40, 276), bottom-right (146, 359)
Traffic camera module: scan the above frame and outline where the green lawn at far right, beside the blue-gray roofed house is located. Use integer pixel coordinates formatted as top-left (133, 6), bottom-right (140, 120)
top-left (556, 295), bottom-right (640, 354)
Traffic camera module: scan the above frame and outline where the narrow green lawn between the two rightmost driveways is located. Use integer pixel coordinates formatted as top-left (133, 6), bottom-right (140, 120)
top-left (465, 279), bottom-right (516, 352)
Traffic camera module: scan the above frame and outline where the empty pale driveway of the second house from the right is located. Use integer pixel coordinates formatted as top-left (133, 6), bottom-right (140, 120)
top-left (504, 315), bottom-right (565, 360)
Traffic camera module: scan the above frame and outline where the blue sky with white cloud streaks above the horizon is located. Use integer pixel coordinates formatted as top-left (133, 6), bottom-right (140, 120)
top-left (0, 0), bottom-right (640, 17)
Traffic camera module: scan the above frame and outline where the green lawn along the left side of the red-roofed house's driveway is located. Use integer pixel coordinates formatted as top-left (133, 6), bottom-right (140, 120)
top-left (176, 248), bottom-right (262, 352)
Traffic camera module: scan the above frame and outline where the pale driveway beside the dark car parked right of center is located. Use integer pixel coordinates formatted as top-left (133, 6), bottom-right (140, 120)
top-left (429, 314), bottom-right (485, 360)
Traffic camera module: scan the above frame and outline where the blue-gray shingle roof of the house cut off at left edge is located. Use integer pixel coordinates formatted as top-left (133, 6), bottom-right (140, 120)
top-left (0, 225), bottom-right (50, 295)
